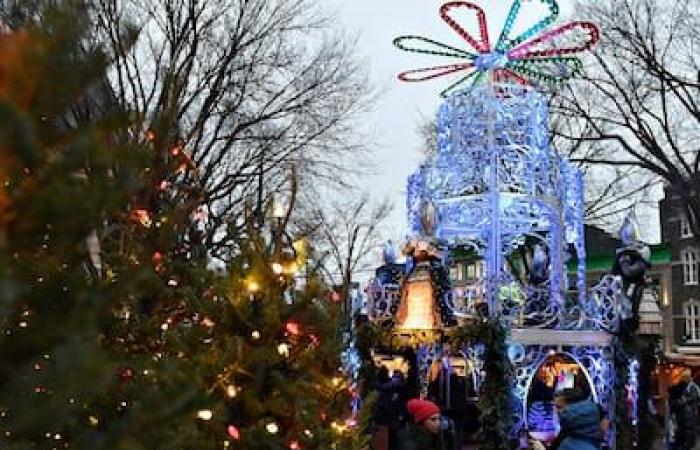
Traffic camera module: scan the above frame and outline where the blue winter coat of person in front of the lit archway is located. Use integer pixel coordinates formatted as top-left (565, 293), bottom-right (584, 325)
top-left (557, 400), bottom-right (603, 450)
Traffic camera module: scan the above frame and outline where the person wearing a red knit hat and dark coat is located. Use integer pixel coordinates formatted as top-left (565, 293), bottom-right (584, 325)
top-left (395, 398), bottom-right (445, 450)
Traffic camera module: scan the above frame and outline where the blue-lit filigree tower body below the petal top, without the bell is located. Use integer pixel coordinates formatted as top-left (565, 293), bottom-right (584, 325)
top-left (407, 84), bottom-right (620, 444)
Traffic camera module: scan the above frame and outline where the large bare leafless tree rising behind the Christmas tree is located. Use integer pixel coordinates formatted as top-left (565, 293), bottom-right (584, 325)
top-left (92, 0), bottom-right (371, 256)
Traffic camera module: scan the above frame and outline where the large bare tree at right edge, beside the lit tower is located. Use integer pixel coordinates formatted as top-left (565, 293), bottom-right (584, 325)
top-left (552, 0), bottom-right (700, 235)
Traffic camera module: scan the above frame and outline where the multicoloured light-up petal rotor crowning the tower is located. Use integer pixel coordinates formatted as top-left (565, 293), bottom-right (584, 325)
top-left (394, 0), bottom-right (600, 97)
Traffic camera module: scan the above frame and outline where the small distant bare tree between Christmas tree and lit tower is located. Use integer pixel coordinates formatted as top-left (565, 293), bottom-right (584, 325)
top-left (306, 194), bottom-right (393, 326)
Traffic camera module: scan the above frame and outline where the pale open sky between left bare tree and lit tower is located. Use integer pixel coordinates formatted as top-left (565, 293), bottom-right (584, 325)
top-left (319, 0), bottom-right (660, 248)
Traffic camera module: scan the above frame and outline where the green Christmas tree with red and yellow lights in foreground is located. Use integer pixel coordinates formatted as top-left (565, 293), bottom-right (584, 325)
top-left (0, 2), bottom-right (365, 450)
